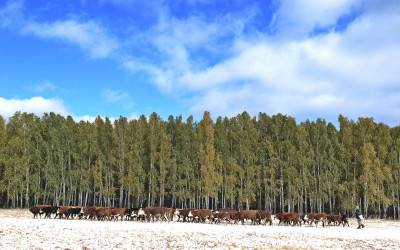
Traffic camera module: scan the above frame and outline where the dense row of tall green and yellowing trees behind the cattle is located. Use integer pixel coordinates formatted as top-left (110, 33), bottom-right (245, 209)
top-left (0, 111), bottom-right (400, 219)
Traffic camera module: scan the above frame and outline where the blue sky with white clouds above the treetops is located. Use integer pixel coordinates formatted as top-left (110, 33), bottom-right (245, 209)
top-left (0, 0), bottom-right (400, 126)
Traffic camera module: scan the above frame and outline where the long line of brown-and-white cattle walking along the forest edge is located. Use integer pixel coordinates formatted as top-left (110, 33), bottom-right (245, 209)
top-left (29, 205), bottom-right (349, 227)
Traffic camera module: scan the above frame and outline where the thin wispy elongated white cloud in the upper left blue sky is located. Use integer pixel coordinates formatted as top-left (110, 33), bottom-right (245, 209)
top-left (24, 20), bottom-right (120, 58)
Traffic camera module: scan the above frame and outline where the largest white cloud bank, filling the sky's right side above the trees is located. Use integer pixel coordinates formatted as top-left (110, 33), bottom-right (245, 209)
top-left (165, 1), bottom-right (400, 125)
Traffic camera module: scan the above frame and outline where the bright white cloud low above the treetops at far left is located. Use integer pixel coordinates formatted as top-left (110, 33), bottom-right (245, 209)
top-left (0, 96), bottom-right (70, 118)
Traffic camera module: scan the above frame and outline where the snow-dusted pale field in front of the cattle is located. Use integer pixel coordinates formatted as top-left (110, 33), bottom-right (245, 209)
top-left (0, 209), bottom-right (400, 249)
